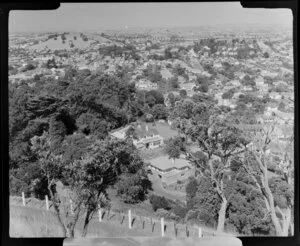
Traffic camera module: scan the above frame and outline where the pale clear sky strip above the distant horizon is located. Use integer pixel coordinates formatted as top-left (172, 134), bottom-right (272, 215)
top-left (9, 2), bottom-right (293, 32)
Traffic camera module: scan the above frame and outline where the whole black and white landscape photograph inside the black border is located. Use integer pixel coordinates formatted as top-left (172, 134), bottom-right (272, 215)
top-left (8, 2), bottom-right (295, 239)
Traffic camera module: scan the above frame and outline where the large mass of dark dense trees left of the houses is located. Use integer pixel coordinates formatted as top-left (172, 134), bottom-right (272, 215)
top-left (9, 68), bottom-right (150, 198)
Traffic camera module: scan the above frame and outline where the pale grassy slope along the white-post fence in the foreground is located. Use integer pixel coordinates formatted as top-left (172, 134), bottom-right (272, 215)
top-left (10, 197), bottom-right (224, 237)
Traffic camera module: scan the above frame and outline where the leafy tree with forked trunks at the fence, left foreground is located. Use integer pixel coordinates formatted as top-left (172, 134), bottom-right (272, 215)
top-left (31, 132), bottom-right (151, 237)
